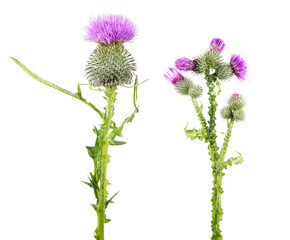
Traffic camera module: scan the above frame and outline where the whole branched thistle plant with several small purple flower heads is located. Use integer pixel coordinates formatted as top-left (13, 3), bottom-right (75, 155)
top-left (164, 38), bottom-right (247, 240)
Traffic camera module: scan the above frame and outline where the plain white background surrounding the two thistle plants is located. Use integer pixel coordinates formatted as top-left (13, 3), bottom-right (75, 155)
top-left (0, 0), bottom-right (290, 240)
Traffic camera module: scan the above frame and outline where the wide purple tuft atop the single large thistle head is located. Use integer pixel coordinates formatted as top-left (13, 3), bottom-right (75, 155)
top-left (85, 15), bottom-right (137, 44)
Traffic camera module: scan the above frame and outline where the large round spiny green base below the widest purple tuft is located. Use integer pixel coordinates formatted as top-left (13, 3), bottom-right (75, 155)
top-left (86, 43), bottom-right (136, 87)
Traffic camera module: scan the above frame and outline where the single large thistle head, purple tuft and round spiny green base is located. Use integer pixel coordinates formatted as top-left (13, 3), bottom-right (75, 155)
top-left (86, 15), bottom-right (137, 87)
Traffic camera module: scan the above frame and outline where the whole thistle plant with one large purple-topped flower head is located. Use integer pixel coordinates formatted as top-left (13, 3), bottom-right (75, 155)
top-left (12, 15), bottom-right (143, 240)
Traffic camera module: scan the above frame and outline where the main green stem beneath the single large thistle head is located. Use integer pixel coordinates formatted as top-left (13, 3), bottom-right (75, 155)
top-left (95, 87), bottom-right (116, 240)
